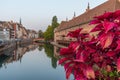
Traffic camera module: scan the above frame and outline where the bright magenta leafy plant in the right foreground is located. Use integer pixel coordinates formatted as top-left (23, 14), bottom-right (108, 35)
top-left (59, 10), bottom-right (120, 80)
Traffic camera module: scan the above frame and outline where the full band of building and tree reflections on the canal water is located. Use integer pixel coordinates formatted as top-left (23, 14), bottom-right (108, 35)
top-left (0, 44), bottom-right (62, 69)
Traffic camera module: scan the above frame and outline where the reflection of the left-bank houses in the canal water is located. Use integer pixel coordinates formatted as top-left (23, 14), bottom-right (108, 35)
top-left (0, 44), bottom-right (38, 68)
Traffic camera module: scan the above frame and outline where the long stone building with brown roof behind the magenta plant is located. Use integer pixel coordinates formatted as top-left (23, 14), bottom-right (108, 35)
top-left (54, 0), bottom-right (120, 42)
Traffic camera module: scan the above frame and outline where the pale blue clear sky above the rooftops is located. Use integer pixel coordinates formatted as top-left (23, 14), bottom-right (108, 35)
top-left (0, 0), bottom-right (107, 31)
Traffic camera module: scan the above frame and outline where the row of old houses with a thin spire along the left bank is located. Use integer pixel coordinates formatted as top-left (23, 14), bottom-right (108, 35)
top-left (0, 19), bottom-right (38, 40)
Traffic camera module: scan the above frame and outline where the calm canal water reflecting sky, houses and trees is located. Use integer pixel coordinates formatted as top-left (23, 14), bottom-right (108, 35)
top-left (0, 44), bottom-right (73, 80)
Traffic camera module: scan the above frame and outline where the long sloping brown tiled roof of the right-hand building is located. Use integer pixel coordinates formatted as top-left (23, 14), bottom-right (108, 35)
top-left (56, 0), bottom-right (120, 31)
